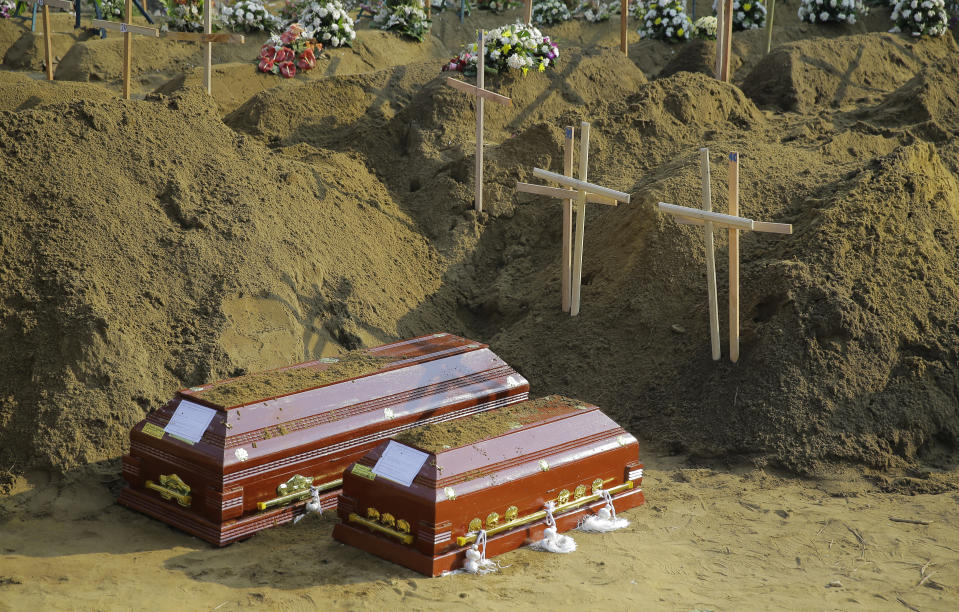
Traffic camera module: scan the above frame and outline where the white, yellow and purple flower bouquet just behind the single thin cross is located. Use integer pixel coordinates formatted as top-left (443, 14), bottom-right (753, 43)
top-left (443, 22), bottom-right (559, 75)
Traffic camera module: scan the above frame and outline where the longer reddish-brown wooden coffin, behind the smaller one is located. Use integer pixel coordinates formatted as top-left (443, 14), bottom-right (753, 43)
top-left (118, 334), bottom-right (529, 545)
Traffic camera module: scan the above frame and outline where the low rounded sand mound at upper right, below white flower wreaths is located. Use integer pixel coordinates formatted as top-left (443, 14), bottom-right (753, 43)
top-left (742, 33), bottom-right (959, 113)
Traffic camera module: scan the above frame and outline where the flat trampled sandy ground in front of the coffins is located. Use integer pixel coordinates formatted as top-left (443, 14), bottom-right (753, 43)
top-left (0, 456), bottom-right (959, 611)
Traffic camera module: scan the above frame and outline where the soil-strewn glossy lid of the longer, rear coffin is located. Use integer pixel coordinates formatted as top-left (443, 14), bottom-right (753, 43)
top-left (137, 333), bottom-right (528, 469)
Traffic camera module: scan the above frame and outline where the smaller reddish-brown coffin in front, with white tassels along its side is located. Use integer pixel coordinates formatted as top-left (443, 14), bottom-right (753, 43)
top-left (333, 396), bottom-right (643, 576)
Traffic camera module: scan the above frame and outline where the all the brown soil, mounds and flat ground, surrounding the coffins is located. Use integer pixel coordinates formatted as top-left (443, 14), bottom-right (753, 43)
top-left (0, 5), bottom-right (959, 610)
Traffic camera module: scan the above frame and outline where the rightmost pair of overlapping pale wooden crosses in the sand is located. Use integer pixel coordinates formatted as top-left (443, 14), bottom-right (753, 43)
top-left (659, 148), bottom-right (793, 363)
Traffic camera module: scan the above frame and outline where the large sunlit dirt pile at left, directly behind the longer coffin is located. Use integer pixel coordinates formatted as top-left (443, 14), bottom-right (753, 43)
top-left (0, 89), bottom-right (439, 468)
